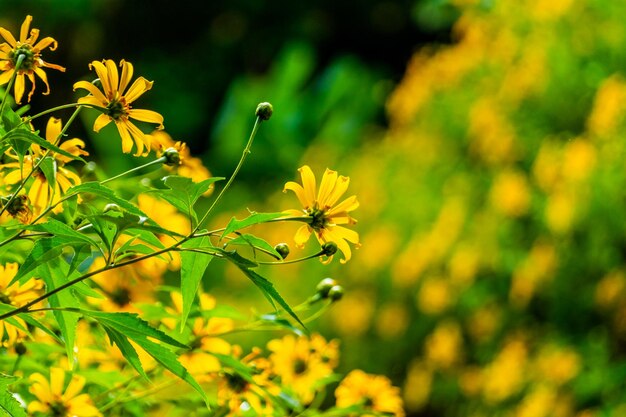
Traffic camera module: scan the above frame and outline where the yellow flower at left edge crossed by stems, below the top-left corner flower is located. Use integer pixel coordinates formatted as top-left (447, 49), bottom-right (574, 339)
top-left (0, 117), bottom-right (89, 213)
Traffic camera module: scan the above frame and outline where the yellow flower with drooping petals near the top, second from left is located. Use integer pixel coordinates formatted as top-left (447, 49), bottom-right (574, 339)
top-left (74, 59), bottom-right (163, 156)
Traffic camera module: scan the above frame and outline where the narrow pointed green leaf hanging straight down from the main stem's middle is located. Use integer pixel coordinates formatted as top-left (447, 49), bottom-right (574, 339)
top-left (180, 236), bottom-right (213, 331)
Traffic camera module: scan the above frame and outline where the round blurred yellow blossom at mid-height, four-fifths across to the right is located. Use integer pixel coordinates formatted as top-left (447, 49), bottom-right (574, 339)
top-left (490, 170), bottom-right (531, 217)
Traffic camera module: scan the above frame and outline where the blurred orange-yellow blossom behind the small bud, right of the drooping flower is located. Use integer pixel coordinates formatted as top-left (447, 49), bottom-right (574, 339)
top-left (150, 130), bottom-right (213, 196)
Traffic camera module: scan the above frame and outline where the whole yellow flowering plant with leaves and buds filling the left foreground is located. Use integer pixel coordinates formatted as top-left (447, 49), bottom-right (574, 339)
top-left (0, 16), bottom-right (404, 417)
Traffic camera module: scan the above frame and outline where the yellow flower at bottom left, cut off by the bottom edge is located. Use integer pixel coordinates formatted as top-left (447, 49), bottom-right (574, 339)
top-left (28, 368), bottom-right (102, 417)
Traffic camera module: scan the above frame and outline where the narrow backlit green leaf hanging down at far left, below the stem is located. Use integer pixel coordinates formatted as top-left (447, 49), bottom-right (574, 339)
top-left (37, 259), bottom-right (79, 364)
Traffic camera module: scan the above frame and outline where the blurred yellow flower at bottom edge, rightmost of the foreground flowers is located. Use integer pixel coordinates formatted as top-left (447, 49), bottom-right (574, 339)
top-left (335, 369), bottom-right (404, 417)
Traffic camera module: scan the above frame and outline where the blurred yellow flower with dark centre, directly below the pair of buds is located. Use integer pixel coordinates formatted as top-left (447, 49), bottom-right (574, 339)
top-left (267, 335), bottom-right (337, 404)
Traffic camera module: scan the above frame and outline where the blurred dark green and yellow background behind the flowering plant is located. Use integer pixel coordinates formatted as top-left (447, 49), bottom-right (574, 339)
top-left (0, 0), bottom-right (626, 417)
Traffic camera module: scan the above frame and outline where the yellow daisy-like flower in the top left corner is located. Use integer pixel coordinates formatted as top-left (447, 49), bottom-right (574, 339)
top-left (0, 15), bottom-right (65, 104)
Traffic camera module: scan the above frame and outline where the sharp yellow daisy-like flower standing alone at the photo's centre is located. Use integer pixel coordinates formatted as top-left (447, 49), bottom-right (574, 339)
top-left (283, 165), bottom-right (359, 263)
